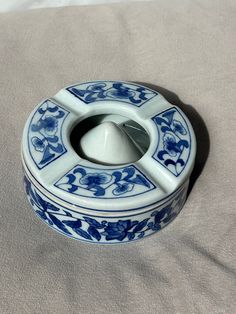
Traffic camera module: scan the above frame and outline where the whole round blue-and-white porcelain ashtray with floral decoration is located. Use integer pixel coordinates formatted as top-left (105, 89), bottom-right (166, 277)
top-left (22, 81), bottom-right (196, 243)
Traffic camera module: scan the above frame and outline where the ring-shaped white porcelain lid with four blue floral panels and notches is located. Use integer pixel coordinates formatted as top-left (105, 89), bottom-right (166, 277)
top-left (22, 81), bottom-right (196, 212)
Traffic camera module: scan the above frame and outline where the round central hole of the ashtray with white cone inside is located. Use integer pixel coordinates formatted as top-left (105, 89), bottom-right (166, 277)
top-left (70, 114), bottom-right (150, 165)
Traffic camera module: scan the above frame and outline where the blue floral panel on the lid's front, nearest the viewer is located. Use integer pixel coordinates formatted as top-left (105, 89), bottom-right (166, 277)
top-left (55, 165), bottom-right (156, 198)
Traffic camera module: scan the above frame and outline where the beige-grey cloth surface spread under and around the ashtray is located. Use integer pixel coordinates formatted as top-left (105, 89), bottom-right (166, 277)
top-left (0, 0), bottom-right (236, 314)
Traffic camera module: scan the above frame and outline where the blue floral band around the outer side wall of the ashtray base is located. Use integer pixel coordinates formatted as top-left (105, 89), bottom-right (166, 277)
top-left (24, 176), bottom-right (186, 243)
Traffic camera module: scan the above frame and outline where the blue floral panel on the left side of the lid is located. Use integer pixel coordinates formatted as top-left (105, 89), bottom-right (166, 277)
top-left (28, 100), bottom-right (69, 169)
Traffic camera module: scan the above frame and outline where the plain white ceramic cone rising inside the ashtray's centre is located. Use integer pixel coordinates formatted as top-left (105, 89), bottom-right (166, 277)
top-left (80, 121), bottom-right (142, 165)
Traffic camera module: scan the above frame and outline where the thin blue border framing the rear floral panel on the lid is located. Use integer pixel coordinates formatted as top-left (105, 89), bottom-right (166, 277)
top-left (66, 81), bottom-right (159, 107)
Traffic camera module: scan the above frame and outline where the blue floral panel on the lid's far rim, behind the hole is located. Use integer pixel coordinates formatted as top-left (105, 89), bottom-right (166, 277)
top-left (67, 81), bottom-right (158, 107)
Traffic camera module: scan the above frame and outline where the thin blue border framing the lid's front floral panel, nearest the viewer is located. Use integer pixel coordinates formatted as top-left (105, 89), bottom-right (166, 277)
top-left (54, 164), bottom-right (157, 199)
